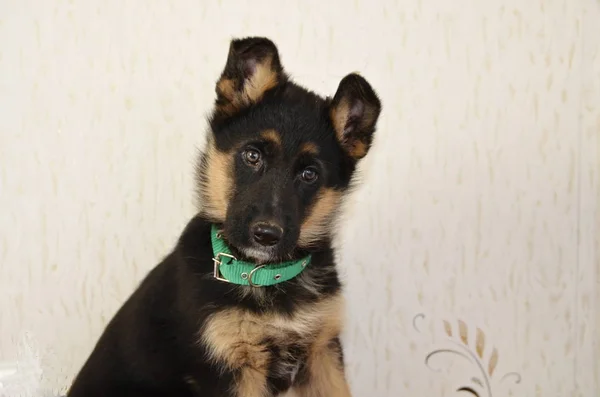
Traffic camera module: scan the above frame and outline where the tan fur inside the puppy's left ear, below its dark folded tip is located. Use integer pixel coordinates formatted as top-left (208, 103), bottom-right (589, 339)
top-left (217, 58), bottom-right (278, 116)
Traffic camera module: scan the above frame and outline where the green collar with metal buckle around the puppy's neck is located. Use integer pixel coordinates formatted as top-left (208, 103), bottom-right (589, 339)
top-left (210, 225), bottom-right (311, 287)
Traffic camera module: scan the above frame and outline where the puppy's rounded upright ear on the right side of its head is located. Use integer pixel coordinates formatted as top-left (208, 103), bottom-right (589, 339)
top-left (329, 73), bottom-right (381, 160)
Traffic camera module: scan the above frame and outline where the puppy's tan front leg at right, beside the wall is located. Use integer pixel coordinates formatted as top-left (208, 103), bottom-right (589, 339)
top-left (294, 338), bottom-right (351, 397)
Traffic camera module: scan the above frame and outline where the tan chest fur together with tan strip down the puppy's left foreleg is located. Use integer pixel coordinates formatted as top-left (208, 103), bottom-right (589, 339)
top-left (200, 295), bottom-right (344, 397)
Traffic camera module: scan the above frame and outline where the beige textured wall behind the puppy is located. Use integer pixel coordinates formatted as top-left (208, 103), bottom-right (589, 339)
top-left (0, 0), bottom-right (600, 397)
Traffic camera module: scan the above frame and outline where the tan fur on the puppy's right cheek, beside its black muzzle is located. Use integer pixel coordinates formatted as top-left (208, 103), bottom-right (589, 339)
top-left (298, 188), bottom-right (342, 247)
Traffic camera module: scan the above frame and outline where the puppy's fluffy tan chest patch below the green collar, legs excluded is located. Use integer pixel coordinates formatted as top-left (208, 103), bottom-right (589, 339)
top-left (202, 300), bottom-right (341, 380)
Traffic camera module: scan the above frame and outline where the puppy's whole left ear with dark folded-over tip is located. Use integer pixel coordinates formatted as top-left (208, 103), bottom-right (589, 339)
top-left (215, 37), bottom-right (285, 117)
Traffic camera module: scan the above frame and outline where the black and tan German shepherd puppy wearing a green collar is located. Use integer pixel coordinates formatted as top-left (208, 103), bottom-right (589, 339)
top-left (68, 37), bottom-right (381, 397)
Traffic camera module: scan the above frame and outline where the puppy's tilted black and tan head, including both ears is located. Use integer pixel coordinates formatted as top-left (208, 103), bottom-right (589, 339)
top-left (199, 38), bottom-right (381, 263)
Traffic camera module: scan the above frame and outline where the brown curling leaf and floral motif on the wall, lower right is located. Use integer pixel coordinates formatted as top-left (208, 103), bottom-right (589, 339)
top-left (413, 313), bottom-right (521, 397)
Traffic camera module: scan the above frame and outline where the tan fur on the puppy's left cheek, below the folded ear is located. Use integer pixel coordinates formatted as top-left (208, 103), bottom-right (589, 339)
top-left (201, 141), bottom-right (233, 221)
